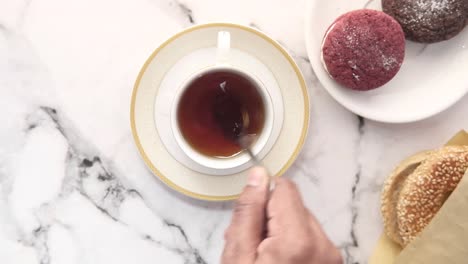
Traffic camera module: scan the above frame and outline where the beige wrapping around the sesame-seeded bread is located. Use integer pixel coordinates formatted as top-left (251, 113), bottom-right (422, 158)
top-left (369, 131), bottom-right (468, 264)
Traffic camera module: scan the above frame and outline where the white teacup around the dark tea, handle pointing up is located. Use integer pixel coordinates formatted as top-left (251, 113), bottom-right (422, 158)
top-left (155, 31), bottom-right (283, 175)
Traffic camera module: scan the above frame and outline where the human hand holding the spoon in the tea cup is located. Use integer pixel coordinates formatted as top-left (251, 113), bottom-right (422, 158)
top-left (221, 167), bottom-right (343, 264)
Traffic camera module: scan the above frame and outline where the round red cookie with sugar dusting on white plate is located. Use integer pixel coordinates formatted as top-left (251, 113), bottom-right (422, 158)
top-left (322, 9), bottom-right (405, 91)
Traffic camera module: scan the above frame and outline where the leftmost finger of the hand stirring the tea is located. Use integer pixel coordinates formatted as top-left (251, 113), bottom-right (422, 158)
top-left (222, 167), bottom-right (269, 264)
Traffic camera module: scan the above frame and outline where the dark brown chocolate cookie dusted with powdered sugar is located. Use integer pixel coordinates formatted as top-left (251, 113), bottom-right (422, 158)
top-left (382, 0), bottom-right (468, 43)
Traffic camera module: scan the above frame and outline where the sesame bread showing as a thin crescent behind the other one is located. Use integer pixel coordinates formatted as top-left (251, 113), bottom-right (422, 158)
top-left (381, 151), bottom-right (432, 245)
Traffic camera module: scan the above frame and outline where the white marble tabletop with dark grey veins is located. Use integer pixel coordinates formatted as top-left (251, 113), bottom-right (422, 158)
top-left (0, 0), bottom-right (468, 264)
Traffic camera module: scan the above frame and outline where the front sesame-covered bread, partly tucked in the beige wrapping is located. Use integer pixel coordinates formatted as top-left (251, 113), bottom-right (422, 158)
top-left (396, 146), bottom-right (468, 246)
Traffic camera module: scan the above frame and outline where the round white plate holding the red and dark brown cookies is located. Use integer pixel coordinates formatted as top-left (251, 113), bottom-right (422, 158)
top-left (305, 0), bottom-right (468, 123)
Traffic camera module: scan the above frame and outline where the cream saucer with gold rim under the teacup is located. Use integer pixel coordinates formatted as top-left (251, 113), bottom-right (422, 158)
top-left (130, 23), bottom-right (309, 200)
